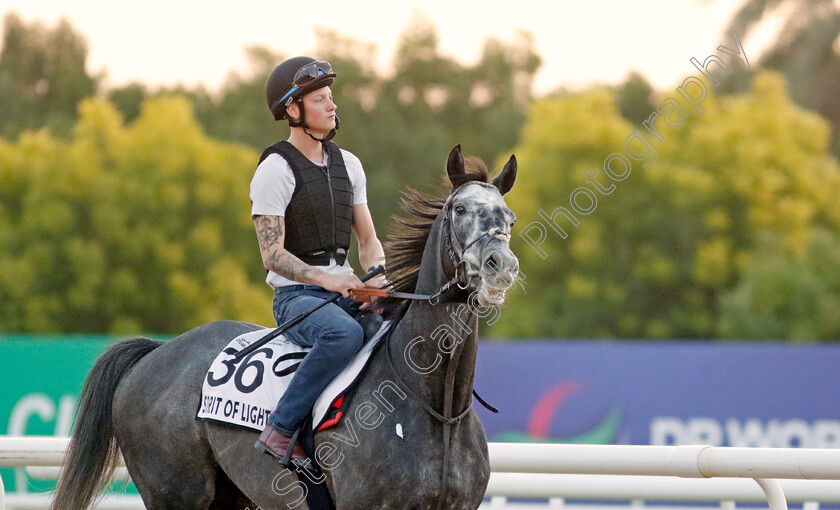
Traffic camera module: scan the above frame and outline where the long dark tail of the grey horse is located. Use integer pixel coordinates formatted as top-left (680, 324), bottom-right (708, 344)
top-left (50, 338), bottom-right (163, 510)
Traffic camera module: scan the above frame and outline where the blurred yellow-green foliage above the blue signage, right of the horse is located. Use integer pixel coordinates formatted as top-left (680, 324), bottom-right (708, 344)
top-left (492, 74), bottom-right (840, 339)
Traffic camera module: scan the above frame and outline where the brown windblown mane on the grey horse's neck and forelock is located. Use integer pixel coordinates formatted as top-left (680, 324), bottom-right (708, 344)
top-left (382, 156), bottom-right (489, 307)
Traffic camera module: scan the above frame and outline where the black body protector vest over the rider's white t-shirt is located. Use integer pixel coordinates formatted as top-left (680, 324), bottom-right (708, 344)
top-left (260, 140), bottom-right (353, 266)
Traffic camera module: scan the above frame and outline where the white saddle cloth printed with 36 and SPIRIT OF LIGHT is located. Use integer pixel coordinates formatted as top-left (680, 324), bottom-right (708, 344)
top-left (195, 321), bottom-right (392, 431)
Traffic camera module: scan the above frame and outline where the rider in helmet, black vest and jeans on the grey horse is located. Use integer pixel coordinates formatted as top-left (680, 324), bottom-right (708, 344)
top-left (251, 57), bottom-right (385, 458)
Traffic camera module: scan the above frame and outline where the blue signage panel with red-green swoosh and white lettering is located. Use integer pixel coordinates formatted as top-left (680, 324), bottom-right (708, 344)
top-left (475, 341), bottom-right (840, 448)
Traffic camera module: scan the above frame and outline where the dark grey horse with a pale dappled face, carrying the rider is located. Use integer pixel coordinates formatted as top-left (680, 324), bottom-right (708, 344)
top-left (51, 146), bottom-right (519, 510)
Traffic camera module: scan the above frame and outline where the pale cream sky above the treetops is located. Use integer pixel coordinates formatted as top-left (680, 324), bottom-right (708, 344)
top-left (0, 0), bottom-right (773, 94)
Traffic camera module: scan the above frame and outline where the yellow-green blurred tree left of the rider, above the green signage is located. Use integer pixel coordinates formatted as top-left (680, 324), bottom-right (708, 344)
top-left (0, 98), bottom-right (271, 334)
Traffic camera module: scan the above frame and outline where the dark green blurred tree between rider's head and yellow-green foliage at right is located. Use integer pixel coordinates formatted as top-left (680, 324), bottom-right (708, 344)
top-left (352, 19), bottom-right (540, 229)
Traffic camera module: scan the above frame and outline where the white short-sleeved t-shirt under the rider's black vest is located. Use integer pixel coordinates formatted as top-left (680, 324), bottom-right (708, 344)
top-left (251, 145), bottom-right (367, 289)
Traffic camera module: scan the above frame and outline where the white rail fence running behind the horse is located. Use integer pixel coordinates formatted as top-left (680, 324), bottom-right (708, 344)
top-left (0, 436), bottom-right (840, 510)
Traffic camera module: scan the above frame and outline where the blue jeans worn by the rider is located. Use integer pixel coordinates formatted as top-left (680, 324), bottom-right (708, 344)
top-left (268, 285), bottom-right (364, 435)
